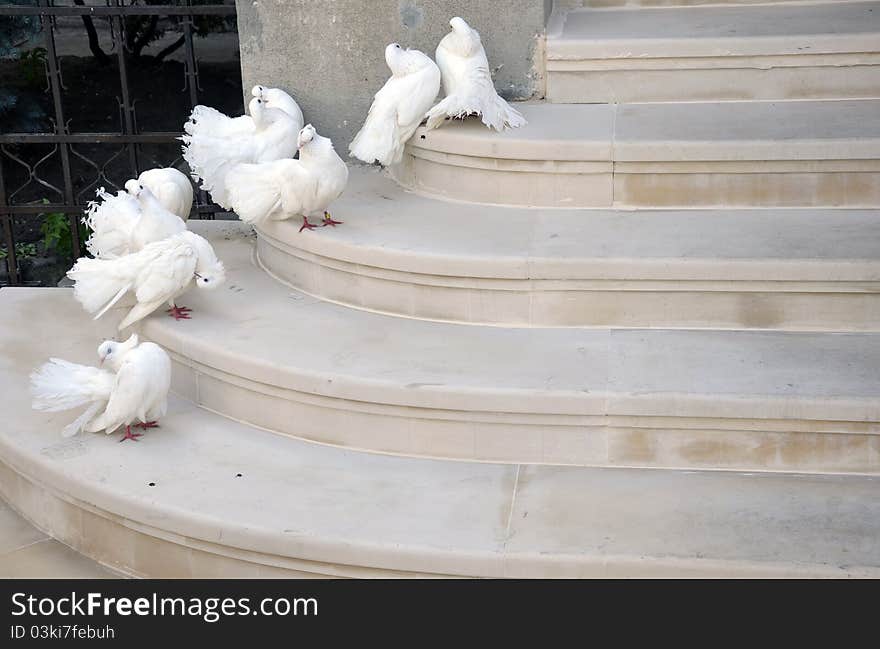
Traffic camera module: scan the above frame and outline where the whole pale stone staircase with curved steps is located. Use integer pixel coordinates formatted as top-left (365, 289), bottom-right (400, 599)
top-left (0, 0), bottom-right (880, 577)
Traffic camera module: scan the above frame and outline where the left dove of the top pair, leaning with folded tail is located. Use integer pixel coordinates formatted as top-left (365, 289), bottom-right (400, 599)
top-left (348, 43), bottom-right (440, 167)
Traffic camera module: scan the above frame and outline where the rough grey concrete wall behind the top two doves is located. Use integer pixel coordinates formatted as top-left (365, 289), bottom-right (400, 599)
top-left (236, 0), bottom-right (551, 148)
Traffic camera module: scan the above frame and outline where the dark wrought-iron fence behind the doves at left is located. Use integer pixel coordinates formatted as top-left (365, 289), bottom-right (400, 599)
top-left (0, 0), bottom-right (235, 285)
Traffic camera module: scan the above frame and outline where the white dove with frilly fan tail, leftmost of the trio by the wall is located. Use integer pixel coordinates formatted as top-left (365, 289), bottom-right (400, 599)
top-left (180, 97), bottom-right (302, 209)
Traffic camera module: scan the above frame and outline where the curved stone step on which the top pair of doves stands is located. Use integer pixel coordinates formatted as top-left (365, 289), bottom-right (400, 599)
top-left (393, 99), bottom-right (880, 208)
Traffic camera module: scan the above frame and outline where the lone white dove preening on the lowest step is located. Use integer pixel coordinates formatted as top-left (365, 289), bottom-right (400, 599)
top-left (31, 334), bottom-right (171, 441)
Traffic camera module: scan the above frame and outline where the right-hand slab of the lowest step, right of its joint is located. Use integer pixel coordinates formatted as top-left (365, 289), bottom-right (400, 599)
top-left (507, 466), bottom-right (877, 577)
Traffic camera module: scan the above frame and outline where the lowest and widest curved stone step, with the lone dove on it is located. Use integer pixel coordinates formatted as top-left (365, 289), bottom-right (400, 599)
top-left (0, 304), bottom-right (880, 578)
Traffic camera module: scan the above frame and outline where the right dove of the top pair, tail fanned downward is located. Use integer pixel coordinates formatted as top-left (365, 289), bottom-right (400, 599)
top-left (427, 16), bottom-right (526, 131)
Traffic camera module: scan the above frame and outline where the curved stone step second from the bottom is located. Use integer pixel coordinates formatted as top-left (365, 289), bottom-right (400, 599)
top-left (13, 222), bottom-right (880, 474)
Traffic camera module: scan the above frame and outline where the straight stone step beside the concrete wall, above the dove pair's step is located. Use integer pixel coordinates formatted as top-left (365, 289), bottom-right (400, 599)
top-left (546, 1), bottom-right (880, 103)
